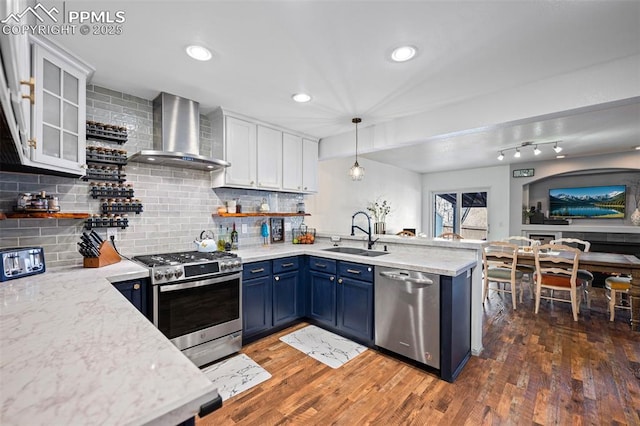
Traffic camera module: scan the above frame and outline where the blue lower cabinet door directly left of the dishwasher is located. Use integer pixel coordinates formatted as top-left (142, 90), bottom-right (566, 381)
top-left (337, 277), bottom-right (373, 344)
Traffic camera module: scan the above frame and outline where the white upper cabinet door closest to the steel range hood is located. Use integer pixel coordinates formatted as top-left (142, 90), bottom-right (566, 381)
top-left (224, 116), bottom-right (256, 187)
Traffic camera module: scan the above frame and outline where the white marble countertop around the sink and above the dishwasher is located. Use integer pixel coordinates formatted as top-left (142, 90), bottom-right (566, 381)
top-left (236, 241), bottom-right (480, 277)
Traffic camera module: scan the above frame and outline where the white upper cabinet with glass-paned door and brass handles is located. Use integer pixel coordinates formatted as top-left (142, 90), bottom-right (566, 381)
top-left (0, 28), bottom-right (93, 176)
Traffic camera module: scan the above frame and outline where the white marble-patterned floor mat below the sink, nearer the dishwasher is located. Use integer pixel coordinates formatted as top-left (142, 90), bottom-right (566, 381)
top-left (280, 325), bottom-right (367, 368)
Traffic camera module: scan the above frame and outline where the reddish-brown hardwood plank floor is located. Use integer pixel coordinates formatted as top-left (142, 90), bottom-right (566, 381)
top-left (196, 289), bottom-right (640, 426)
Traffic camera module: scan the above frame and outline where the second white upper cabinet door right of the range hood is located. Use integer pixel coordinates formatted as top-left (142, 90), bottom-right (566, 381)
top-left (258, 125), bottom-right (282, 190)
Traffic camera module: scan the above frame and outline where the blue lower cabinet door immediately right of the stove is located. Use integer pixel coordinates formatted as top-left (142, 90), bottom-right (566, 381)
top-left (242, 275), bottom-right (273, 339)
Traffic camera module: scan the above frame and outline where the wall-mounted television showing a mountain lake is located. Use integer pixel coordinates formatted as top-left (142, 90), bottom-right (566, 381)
top-left (549, 185), bottom-right (627, 219)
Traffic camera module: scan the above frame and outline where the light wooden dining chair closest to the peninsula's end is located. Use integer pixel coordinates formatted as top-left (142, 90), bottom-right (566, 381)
top-left (482, 241), bottom-right (522, 310)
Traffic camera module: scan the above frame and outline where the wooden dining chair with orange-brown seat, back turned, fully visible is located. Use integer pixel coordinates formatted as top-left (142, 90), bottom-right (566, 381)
top-left (533, 244), bottom-right (582, 321)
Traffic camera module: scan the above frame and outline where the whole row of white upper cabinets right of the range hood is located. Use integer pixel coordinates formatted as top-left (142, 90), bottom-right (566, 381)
top-left (209, 108), bottom-right (318, 193)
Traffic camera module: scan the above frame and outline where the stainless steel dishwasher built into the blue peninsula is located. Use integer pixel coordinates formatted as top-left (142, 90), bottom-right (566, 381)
top-left (374, 266), bottom-right (440, 369)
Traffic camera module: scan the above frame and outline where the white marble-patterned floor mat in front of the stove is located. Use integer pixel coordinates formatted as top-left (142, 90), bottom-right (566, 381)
top-left (202, 354), bottom-right (271, 401)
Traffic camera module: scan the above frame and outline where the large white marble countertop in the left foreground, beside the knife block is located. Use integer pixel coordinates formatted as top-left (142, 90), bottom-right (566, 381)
top-left (0, 260), bottom-right (218, 425)
